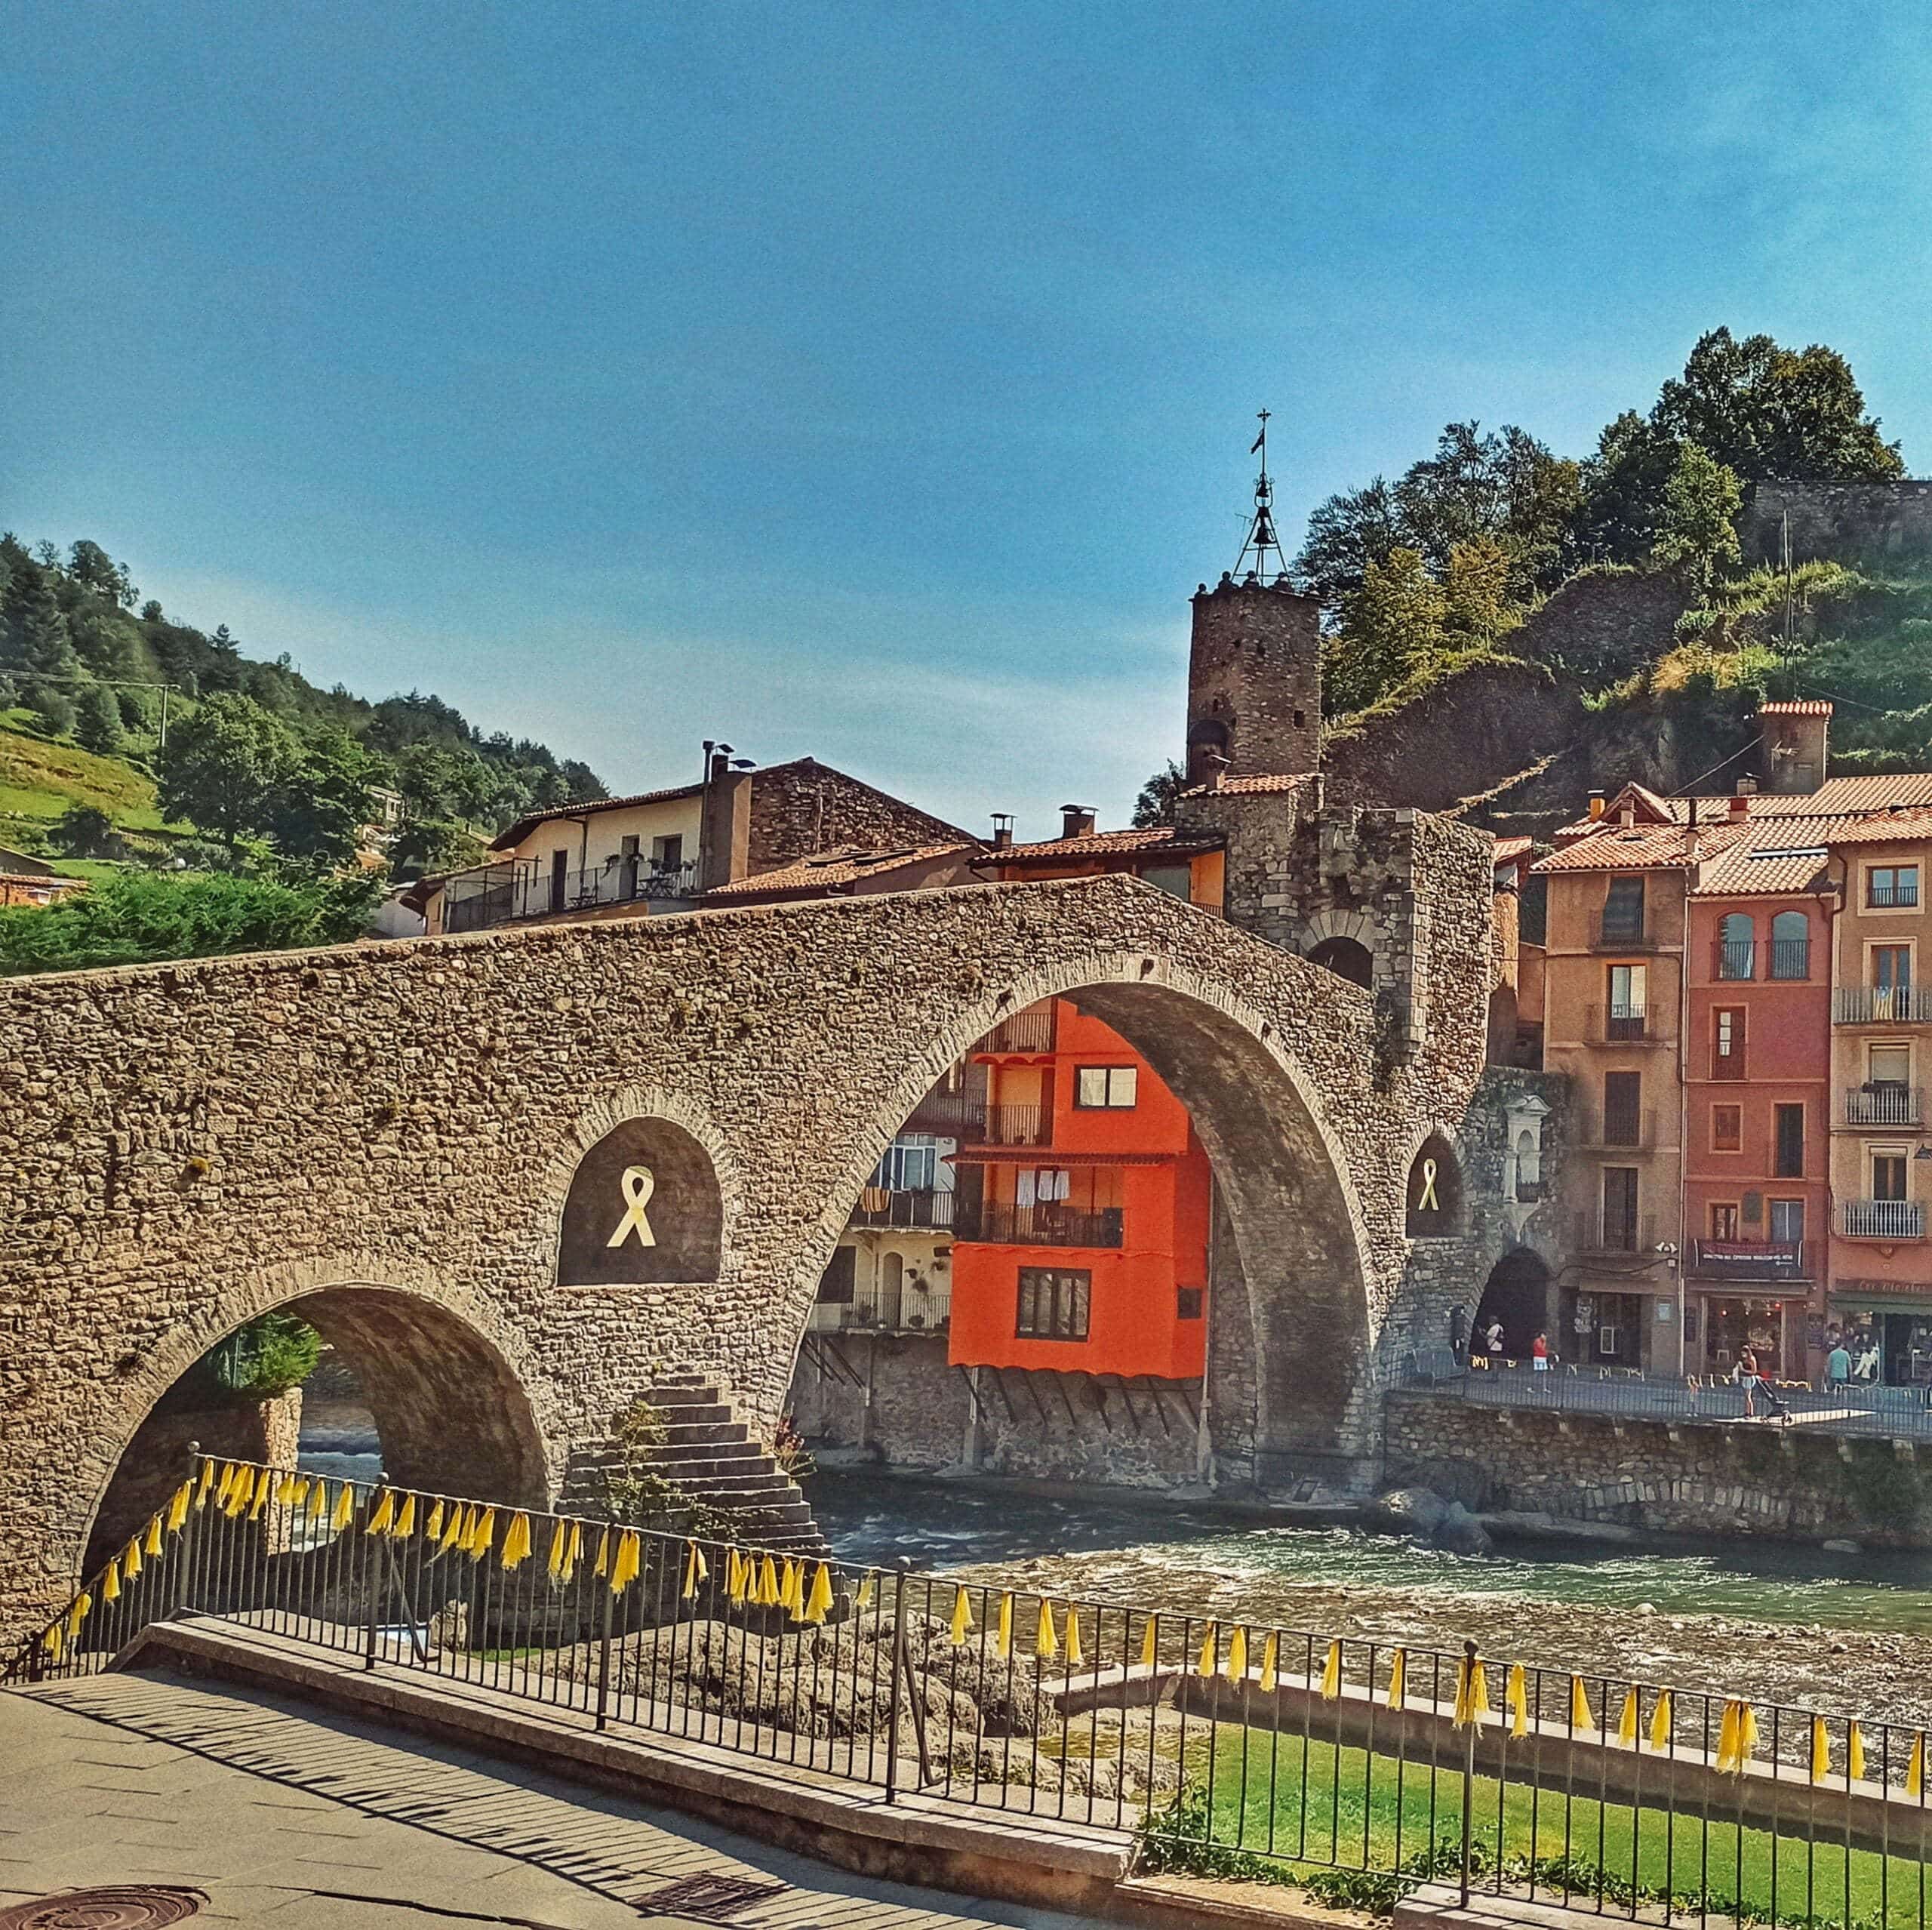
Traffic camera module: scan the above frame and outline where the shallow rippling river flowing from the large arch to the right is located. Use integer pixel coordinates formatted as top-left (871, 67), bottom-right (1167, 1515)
top-left (810, 1470), bottom-right (1932, 1723)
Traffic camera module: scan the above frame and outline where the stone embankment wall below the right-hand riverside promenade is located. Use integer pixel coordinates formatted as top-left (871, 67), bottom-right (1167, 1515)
top-left (1383, 1393), bottom-right (1932, 1546)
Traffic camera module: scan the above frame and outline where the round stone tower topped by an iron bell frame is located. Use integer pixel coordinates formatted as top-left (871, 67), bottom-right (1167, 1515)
top-left (1186, 410), bottom-right (1321, 784)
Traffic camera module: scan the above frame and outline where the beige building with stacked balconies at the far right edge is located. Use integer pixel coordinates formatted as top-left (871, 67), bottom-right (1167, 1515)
top-left (1829, 804), bottom-right (1932, 1387)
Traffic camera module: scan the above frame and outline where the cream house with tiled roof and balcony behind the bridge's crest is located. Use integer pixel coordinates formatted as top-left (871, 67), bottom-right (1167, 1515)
top-left (400, 748), bottom-right (980, 935)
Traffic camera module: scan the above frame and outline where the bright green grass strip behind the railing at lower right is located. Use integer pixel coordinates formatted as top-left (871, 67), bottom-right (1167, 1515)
top-left (1144, 1729), bottom-right (1932, 1926)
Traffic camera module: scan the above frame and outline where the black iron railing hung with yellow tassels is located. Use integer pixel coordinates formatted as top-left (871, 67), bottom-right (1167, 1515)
top-left (6, 1452), bottom-right (1932, 1930)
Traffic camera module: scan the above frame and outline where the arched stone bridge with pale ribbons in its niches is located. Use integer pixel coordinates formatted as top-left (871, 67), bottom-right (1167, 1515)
top-left (0, 869), bottom-right (1537, 1629)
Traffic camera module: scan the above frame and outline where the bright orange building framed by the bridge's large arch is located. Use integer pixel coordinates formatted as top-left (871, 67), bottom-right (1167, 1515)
top-left (949, 999), bottom-right (1211, 1380)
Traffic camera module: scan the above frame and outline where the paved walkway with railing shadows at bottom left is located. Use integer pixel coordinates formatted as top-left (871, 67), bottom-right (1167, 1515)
top-left (0, 1675), bottom-right (1074, 1930)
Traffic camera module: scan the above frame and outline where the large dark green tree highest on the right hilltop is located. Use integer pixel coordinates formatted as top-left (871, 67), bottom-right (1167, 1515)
top-left (1650, 328), bottom-right (1905, 483)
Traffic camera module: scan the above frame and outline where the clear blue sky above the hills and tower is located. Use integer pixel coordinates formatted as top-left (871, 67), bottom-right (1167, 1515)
top-left (0, 0), bottom-right (1932, 835)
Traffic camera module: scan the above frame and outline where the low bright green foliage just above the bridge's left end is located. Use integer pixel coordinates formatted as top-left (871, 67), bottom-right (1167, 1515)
top-left (0, 871), bottom-right (380, 977)
